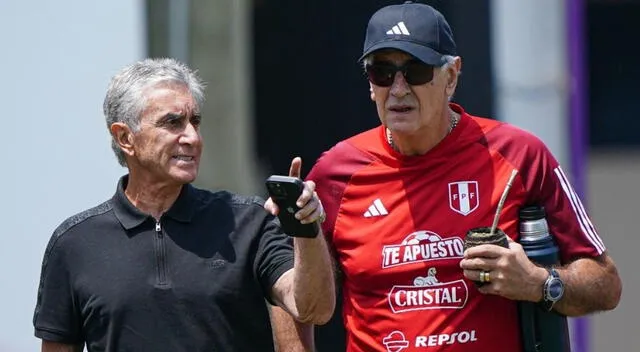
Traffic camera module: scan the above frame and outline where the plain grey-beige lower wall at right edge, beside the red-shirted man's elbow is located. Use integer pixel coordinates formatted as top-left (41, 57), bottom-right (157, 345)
top-left (587, 150), bottom-right (640, 352)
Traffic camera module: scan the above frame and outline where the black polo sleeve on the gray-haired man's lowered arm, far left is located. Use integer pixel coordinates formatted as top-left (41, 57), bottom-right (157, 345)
top-left (33, 234), bottom-right (83, 344)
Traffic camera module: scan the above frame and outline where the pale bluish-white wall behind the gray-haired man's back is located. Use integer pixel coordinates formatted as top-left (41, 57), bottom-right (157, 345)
top-left (0, 0), bottom-right (145, 352)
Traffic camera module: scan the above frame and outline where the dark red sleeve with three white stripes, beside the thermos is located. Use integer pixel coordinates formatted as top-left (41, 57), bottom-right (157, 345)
top-left (529, 142), bottom-right (606, 263)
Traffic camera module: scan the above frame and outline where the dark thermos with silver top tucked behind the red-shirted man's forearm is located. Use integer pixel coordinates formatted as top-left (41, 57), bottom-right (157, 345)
top-left (518, 206), bottom-right (571, 352)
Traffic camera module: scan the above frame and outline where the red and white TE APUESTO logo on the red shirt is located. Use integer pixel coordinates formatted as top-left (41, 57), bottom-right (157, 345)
top-left (382, 231), bottom-right (464, 268)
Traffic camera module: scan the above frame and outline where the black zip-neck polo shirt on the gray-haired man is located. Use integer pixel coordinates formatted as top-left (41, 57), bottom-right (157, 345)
top-left (33, 176), bottom-right (293, 352)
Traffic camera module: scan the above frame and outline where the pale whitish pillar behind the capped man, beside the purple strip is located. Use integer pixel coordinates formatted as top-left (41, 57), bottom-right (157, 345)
top-left (492, 0), bottom-right (573, 168)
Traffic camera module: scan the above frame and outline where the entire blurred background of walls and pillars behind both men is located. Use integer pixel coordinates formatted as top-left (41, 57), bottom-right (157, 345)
top-left (0, 0), bottom-right (640, 352)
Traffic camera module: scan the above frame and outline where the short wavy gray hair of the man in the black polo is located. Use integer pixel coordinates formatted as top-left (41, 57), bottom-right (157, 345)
top-left (102, 58), bottom-right (204, 167)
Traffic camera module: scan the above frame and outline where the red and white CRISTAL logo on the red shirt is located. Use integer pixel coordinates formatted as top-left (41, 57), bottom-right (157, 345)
top-left (387, 268), bottom-right (469, 313)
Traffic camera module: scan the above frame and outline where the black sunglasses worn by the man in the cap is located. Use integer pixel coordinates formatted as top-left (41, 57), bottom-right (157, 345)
top-left (365, 60), bottom-right (433, 87)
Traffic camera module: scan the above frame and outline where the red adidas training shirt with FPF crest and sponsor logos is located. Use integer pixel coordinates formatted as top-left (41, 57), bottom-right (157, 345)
top-left (308, 104), bottom-right (605, 352)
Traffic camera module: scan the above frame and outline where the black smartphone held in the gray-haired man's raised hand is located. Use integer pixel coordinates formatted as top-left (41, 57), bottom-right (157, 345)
top-left (265, 175), bottom-right (320, 238)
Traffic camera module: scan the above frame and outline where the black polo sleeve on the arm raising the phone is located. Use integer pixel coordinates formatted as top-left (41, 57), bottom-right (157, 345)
top-left (254, 215), bottom-right (293, 304)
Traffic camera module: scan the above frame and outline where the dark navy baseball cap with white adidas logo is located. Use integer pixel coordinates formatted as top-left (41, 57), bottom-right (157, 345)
top-left (358, 1), bottom-right (456, 66)
